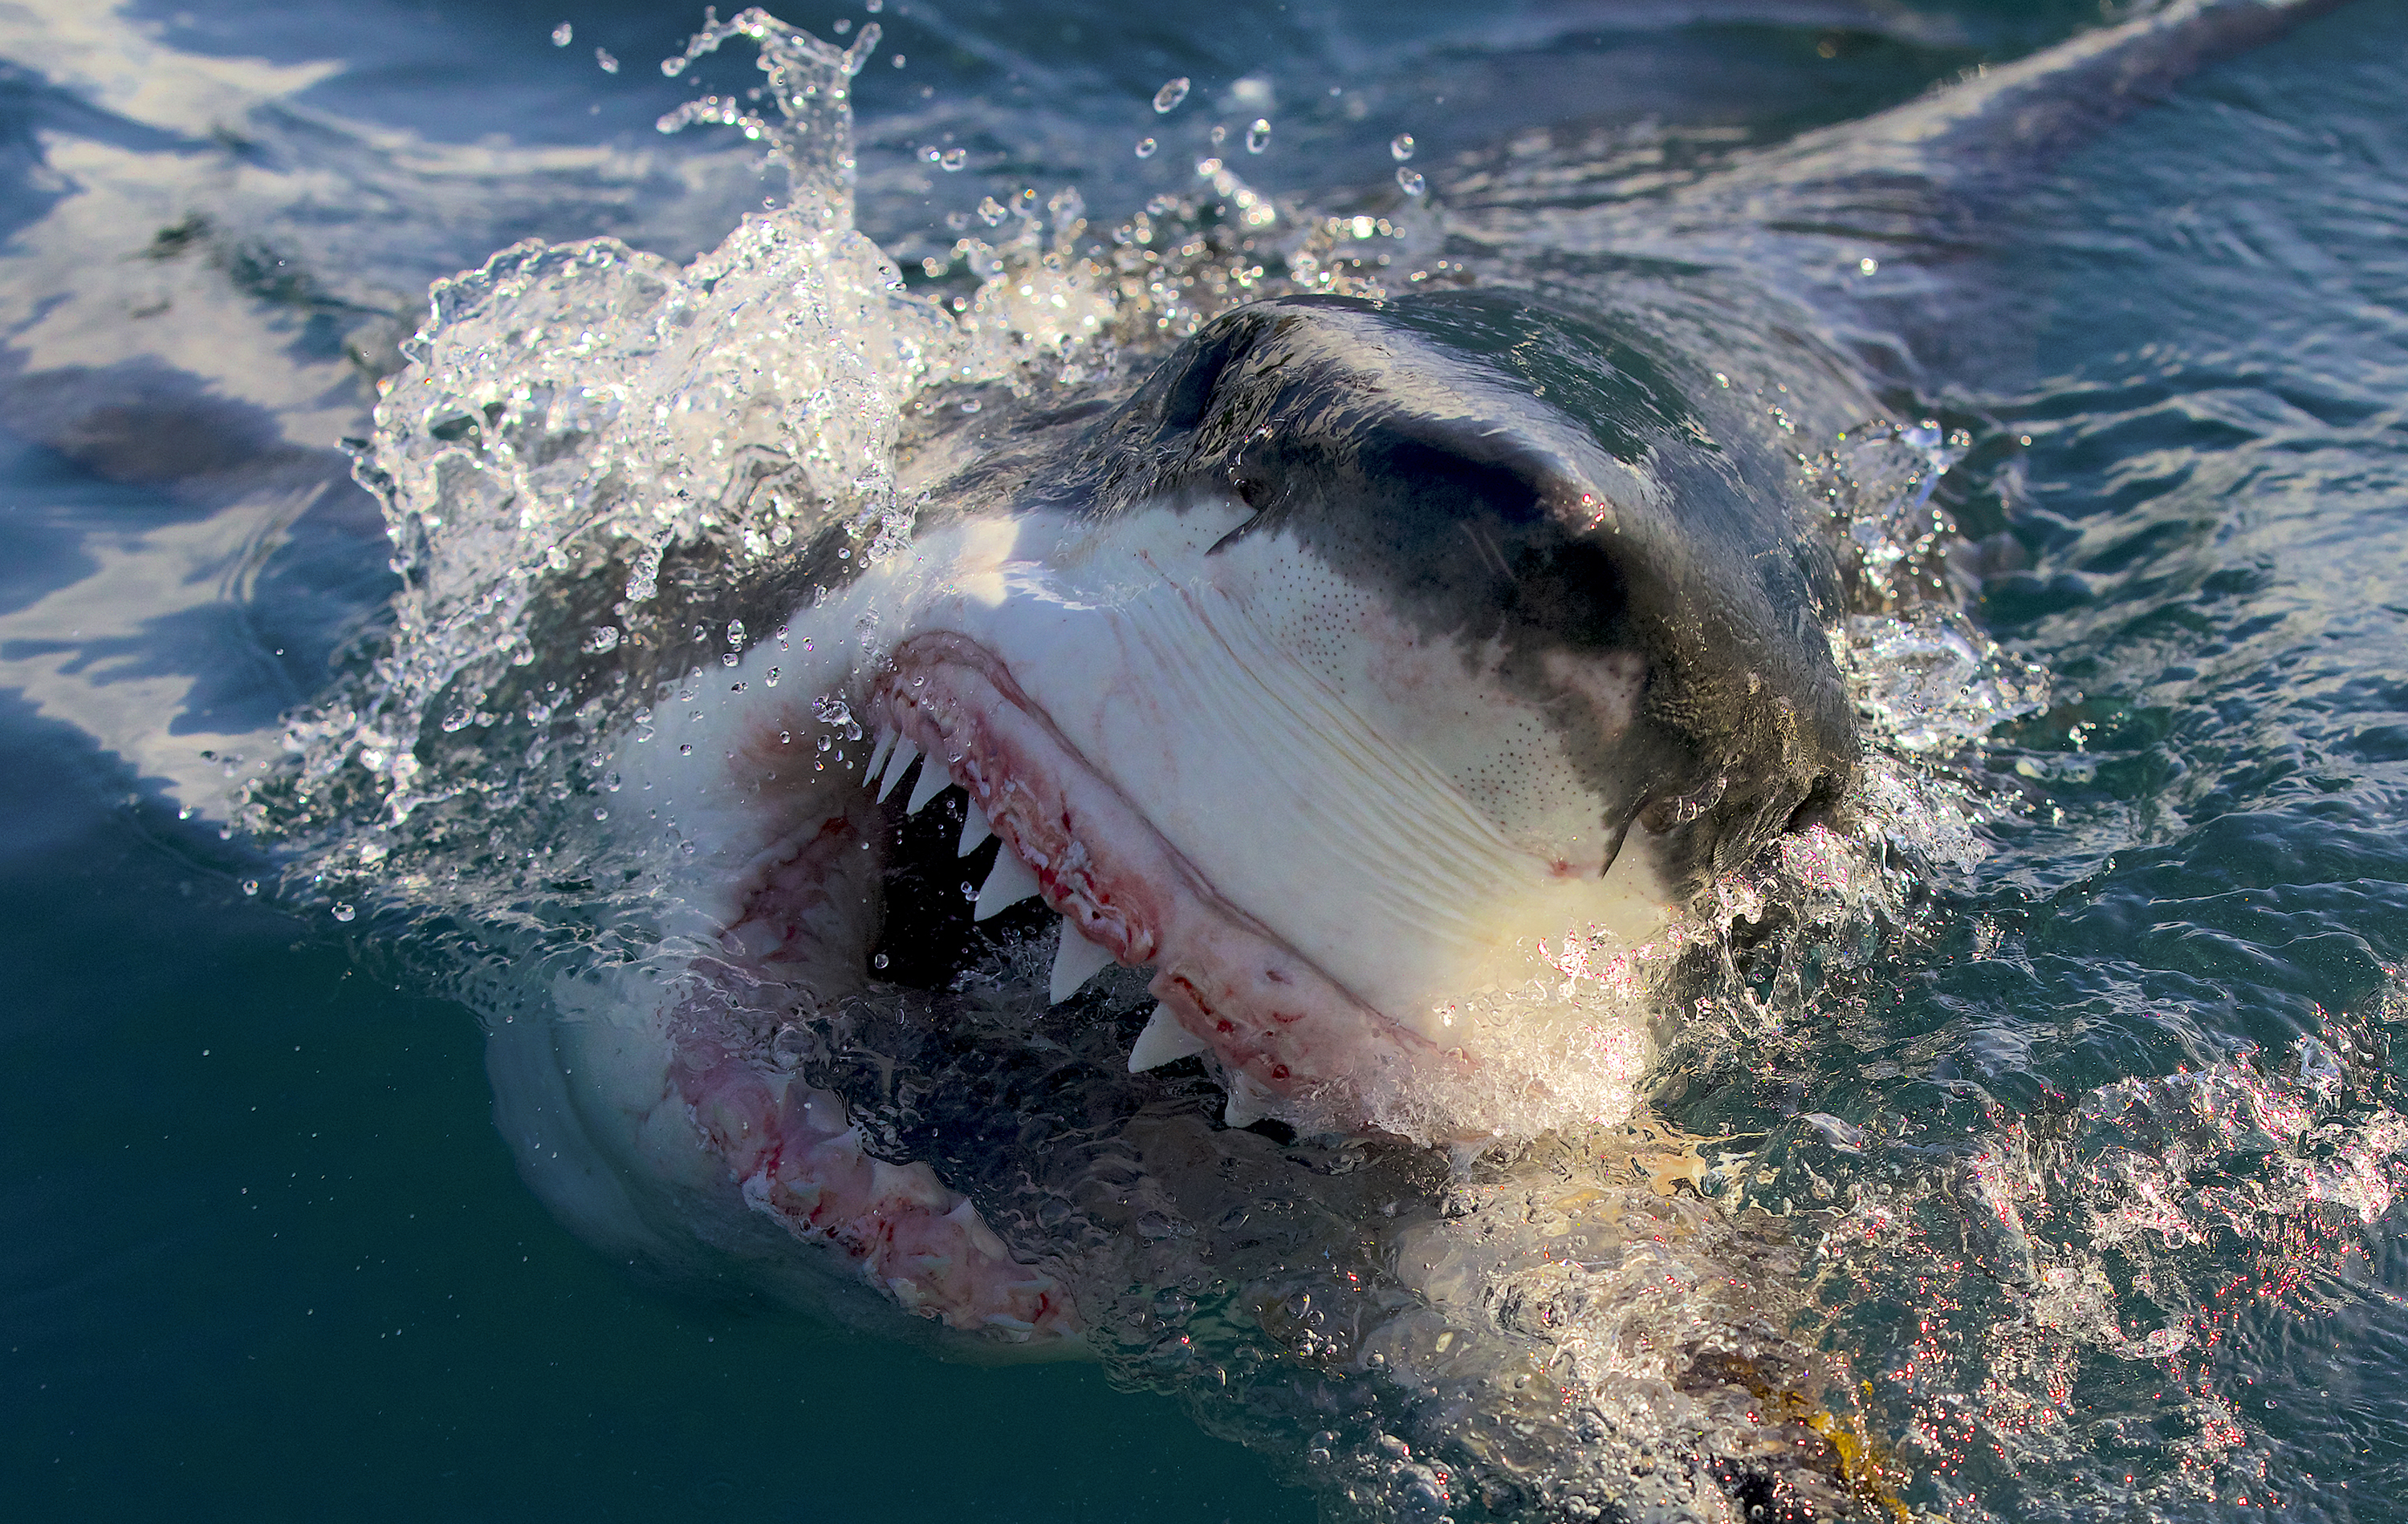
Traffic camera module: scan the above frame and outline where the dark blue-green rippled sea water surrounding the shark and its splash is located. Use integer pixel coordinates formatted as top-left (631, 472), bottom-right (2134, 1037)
top-left (0, 0), bottom-right (2408, 1522)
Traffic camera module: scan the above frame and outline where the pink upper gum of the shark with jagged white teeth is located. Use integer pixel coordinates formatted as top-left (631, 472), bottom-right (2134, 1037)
top-left (869, 631), bottom-right (1466, 1124)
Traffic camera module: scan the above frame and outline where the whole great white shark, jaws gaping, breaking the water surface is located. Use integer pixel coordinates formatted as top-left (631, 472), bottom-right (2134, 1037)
top-left (291, 5), bottom-right (2341, 1519)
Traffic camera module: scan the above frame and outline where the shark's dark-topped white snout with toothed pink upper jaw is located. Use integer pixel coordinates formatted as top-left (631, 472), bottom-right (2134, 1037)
top-left (645, 294), bottom-right (1857, 1136)
